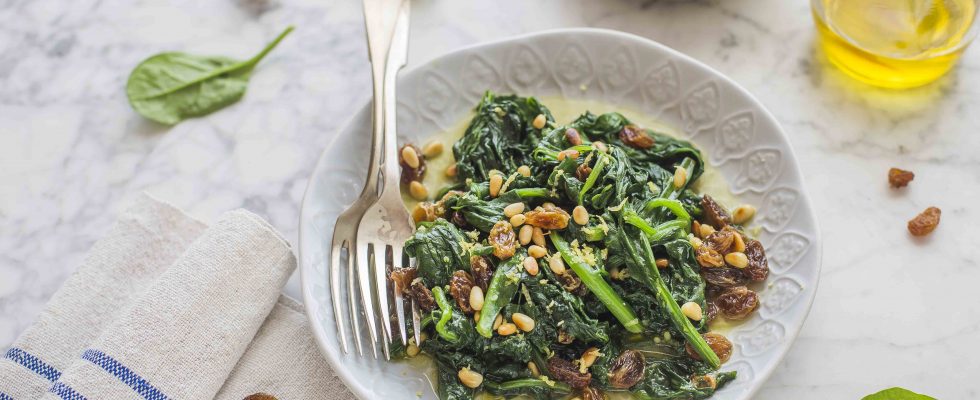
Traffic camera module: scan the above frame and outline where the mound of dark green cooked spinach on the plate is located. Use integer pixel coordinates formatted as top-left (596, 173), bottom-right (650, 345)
top-left (396, 92), bottom-right (756, 400)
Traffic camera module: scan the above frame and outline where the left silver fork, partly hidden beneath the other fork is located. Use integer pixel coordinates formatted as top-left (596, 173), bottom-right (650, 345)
top-left (330, 0), bottom-right (402, 358)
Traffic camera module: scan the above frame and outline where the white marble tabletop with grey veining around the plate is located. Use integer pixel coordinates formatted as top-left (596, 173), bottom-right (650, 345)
top-left (0, 0), bottom-right (980, 399)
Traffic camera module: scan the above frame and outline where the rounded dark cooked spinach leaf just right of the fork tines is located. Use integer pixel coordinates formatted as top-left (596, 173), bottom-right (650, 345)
top-left (405, 218), bottom-right (470, 286)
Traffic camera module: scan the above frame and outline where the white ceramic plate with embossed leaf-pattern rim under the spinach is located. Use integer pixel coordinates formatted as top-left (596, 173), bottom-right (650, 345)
top-left (299, 29), bottom-right (820, 399)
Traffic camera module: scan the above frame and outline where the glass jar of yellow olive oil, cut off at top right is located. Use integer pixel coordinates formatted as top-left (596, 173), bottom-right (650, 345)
top-left (811, 0), bottom-right (978, 88)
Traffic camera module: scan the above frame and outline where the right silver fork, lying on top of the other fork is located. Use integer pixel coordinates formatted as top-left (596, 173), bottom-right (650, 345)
top-left (354, 0), bottom-right (415, 359)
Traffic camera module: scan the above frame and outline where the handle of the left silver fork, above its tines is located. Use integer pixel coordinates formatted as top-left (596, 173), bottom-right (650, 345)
top-left (361, 0), bottom-right (402, 196)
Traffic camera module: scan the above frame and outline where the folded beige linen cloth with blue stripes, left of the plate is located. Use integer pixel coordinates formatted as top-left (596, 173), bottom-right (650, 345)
top-left (0, 196), bottom-right (353, 400)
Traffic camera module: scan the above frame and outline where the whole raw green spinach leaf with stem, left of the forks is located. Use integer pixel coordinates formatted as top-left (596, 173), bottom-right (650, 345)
top-left (126, 26), bottom-right (293, 125)
